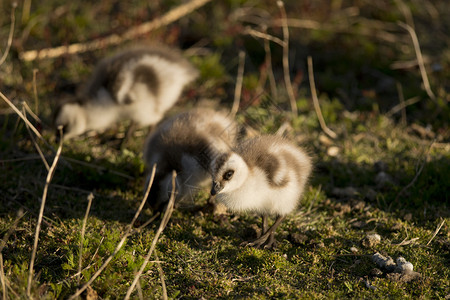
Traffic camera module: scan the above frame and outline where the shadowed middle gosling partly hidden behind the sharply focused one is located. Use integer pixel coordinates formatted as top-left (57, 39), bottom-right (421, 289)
top-left (144, 109), bottom-right (238, 212)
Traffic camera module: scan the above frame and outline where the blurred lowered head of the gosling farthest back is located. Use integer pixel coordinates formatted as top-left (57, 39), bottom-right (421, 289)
top-left (54, 102), bottom-right (86, 140)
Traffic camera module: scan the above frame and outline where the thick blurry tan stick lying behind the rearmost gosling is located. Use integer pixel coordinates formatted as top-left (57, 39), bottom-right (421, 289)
top-left (20, 0), bottom-right (211, 61)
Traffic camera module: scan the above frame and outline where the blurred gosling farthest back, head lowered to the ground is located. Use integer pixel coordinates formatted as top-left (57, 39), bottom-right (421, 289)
top-left (54, 46), bottom-right (198, 139)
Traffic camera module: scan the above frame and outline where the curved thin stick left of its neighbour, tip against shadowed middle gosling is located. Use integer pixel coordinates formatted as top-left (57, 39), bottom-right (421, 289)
top-left (69, 164), bottom-right (156, 300)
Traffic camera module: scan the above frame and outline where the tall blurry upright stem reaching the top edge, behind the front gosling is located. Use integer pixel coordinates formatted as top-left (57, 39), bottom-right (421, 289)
top-left (277, 0), bottom-right (298, 117)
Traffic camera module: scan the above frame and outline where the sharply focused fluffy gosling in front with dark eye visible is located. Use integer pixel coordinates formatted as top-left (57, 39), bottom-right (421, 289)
top-left (211, 135), bottom-right (312, 248)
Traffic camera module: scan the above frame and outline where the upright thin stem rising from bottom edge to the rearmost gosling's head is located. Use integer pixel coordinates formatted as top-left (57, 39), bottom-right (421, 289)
top-left (27, 128), bottom-right (62, 298)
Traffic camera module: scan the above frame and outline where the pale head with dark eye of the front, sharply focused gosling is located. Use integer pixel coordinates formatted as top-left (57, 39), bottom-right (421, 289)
top-left (211, 152), bottom-right (250, 196)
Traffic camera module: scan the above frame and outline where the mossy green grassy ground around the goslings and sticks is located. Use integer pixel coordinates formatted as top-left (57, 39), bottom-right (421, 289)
top-left (0, 0), bottom-right (450, 299)
